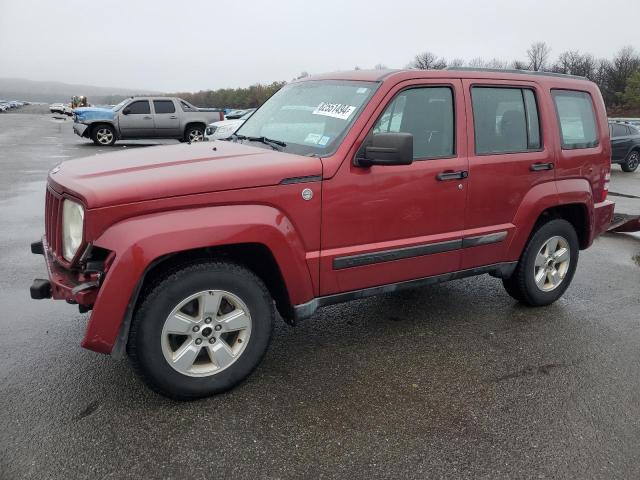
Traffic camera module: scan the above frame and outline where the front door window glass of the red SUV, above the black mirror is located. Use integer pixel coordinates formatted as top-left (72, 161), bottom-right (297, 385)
top-left (373, 87), bottom-right (455, 160)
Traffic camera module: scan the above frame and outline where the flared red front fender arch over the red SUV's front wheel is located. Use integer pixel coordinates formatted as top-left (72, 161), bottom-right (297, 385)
top-left (82, 205), bottom-right (314, 353)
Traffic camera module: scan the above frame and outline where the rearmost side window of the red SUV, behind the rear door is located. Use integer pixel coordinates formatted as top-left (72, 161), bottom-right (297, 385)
top-left (552, 90), bottom-right (596, 150)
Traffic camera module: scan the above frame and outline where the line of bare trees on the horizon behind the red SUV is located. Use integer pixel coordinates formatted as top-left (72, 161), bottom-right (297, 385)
top-left (166, 42), bottom-right (640, 115)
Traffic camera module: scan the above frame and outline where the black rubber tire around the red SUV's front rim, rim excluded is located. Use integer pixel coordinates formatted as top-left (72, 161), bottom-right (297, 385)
top-left (127, 261), bottom-right (275, 400)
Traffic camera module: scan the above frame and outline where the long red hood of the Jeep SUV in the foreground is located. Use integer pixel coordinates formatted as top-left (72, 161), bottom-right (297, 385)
top-left (49, 141), bottom-right (322, 208)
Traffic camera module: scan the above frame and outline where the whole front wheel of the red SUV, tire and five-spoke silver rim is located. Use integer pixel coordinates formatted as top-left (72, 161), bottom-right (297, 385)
top-left (127, 262), bottom-right (275, 400)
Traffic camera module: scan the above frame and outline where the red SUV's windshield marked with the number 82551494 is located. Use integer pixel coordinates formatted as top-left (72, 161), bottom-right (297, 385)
top-left (236, 80), bottom-right (379, 156)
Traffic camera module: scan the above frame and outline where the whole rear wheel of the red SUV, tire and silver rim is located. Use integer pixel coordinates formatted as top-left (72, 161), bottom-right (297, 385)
top-left (502, 219), bottom-right (580, 307)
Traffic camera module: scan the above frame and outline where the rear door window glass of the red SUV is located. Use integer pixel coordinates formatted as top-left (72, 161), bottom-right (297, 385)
top-left (471, 87), bottom-right (542, 155)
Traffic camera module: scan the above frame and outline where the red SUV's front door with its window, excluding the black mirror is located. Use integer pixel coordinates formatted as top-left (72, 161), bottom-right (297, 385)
top-left (320, 79), bottom-right (468, 295)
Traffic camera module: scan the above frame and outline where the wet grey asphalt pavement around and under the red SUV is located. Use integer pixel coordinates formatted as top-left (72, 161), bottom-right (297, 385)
top-left (0, 110), bottom-right (640, 479)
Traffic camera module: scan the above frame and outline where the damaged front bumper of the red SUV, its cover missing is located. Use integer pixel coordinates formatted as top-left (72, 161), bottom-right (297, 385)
top-left (30, 237), bottom-right (100, 311)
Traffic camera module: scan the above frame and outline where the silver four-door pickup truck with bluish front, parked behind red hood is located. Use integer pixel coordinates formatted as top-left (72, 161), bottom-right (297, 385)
top-left (73, 97), bottom-right (224, 146)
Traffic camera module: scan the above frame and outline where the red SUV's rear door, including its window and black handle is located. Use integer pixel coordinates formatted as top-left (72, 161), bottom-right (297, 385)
top-left (462, 79), bottom-right (555, 269)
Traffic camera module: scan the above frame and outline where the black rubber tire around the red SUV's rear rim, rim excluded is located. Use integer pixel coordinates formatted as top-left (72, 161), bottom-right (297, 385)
top-left (502, 219), bottom-right (580, 307)
